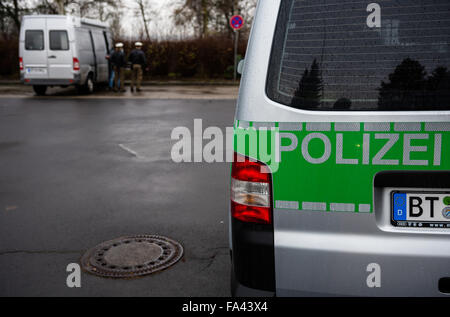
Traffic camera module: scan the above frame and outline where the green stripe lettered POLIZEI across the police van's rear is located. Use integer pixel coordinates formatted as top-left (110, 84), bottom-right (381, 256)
top-left (234, 121), bottom-right (450, 213)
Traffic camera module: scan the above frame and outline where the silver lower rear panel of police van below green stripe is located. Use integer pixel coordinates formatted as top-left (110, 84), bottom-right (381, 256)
top-left (275, 210), bottom-right (450, 296)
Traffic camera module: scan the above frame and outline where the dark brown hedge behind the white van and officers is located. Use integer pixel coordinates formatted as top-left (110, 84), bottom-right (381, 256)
top-left (0, 36), bottom-right (247, 79)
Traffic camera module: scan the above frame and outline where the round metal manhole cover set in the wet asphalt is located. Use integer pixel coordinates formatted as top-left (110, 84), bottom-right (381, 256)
top-left (81, 235), bottom-right (183, 278)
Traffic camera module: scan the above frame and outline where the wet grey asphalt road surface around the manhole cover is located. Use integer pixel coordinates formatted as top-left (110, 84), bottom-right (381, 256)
top-left (0, 97), bottom-right (235, 296)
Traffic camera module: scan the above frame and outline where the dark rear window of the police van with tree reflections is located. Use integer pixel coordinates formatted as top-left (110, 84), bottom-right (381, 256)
top-left (266, 0), bottom-right (450, 111)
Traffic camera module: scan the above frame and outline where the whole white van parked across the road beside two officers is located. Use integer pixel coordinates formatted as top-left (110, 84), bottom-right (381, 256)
top-left (19, 15), bottom-right (112, 95)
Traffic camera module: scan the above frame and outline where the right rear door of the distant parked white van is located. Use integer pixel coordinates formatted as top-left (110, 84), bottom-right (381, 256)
top-left (47, 18), bottom-right (73, 79)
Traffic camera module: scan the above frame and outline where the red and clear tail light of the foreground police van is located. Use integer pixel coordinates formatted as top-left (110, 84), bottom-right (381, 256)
top-left (231, 153), bottom-right (272, 224)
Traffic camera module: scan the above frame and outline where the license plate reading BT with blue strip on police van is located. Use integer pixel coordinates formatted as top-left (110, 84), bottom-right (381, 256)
top-left (392, 191), bottom-right (450, 229)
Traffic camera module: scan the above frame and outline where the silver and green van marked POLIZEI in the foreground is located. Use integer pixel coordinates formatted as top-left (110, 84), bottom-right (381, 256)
top-left (230, 0), bottom-right (450, 296)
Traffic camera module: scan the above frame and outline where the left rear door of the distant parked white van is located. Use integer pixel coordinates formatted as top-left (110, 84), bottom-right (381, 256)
top-left (21, 18), bottom-right (48, 79)
